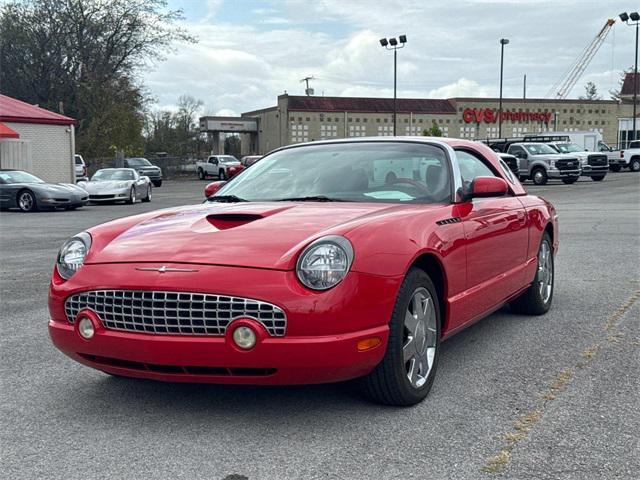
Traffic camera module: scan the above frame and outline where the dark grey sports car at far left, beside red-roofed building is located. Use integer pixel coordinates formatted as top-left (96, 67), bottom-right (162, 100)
top-left (0, 169), bottom-right (89, 212)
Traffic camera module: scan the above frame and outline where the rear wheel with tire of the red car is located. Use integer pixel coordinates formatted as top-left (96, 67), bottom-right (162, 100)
top-left (510, 232), bottom-right (555, 315)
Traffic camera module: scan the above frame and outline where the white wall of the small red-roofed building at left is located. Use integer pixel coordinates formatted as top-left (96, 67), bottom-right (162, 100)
top-left (3, 122), bottom-right (75, 183)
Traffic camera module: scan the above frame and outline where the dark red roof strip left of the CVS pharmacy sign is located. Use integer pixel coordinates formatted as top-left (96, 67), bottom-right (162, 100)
top-left (288, 96), bottom-right (456, 115)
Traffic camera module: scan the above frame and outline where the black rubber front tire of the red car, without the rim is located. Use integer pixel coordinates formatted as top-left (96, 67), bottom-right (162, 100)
top-left (361, 268), bottom-right (441, 406)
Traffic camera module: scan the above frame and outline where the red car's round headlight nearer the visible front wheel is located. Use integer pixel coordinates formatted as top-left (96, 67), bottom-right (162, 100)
top-left (296, 235), bottom-right (353, 290)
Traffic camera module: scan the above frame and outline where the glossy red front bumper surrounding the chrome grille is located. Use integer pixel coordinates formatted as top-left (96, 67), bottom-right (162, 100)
top-left (49, 264), bottom-right (402, 385)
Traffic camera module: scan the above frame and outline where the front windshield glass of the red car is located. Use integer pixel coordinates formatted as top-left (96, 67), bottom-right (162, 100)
top-left (210, 141), bottom-right (451, 203)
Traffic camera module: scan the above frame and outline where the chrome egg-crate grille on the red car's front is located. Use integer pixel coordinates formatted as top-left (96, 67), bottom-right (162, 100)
top-left (65, 290), bottom-right (287, 337)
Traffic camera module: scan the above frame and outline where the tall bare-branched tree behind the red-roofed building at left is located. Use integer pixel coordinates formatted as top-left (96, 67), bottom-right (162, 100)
top-left (0, 0), bottom-right (195, 156)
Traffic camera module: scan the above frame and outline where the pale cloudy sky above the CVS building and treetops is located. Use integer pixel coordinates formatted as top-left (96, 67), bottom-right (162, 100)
top-left (148, 0), bottom-right (638, 115)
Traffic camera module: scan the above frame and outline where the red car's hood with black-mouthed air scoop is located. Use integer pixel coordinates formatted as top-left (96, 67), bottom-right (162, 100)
top-left (85, 202), bottom-right (438, 270)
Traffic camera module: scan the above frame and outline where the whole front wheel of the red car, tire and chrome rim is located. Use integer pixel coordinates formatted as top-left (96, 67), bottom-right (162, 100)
top-left (363, 268), bottom-right (440, 406)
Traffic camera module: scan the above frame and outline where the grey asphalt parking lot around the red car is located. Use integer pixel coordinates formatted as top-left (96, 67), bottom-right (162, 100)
top-left (0, 172), bottom-right (640, 480)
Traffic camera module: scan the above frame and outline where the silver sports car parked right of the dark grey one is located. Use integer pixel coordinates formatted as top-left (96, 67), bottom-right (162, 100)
top-left (78, 168), bottom-right (152, 204)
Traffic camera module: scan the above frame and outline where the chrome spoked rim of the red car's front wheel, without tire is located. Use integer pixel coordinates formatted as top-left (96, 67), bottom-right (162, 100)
top-left (402, 287), bottom-right (437, 388)
